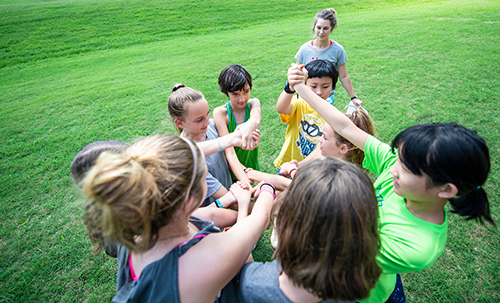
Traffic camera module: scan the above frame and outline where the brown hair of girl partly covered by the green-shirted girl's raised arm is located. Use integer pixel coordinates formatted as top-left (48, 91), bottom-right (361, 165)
top-left (333, 108), bottom-right (375, 166)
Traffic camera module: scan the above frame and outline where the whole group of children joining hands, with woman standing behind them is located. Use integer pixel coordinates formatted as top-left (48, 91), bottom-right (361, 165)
top-left (71, 9), bottom-right (494, 302)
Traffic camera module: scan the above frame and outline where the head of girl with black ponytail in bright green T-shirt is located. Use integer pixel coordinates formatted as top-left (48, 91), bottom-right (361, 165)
top-left (391, 123), bottom-right (494, 224)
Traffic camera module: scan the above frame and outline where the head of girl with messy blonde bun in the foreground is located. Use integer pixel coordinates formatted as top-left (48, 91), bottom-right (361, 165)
top-left (82, 135), bottom-right (207, 252)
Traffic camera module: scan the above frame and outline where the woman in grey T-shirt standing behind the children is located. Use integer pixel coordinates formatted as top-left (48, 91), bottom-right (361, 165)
top-left (295, 8), bottom-right (363, 110)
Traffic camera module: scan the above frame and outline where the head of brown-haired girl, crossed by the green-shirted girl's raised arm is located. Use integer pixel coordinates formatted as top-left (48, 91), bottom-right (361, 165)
top-left (319, 109), bottom-right (375, 166)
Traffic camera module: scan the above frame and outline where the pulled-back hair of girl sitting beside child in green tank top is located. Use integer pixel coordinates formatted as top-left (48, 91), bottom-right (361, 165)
top-left (168, 83), bottom-right (203, 133)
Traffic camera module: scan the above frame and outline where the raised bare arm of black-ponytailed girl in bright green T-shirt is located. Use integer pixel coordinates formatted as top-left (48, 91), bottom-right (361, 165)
top-left (294, 67), bottom-right (368, 150)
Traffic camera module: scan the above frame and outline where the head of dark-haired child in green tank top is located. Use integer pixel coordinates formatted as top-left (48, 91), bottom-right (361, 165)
top-left (219, 64), bottom-right (252, 107)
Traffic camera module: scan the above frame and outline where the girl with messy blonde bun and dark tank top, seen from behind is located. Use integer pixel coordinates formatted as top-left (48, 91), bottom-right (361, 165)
top-left (81, 135), bottom-right (274, 302)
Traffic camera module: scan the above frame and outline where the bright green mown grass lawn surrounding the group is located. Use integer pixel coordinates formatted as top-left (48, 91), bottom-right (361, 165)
top-left (0, 0), bottom-right (500, 302)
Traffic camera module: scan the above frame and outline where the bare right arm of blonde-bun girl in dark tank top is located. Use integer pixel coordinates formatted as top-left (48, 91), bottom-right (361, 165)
top-left (178, 185), bottom-right (274, 302)
